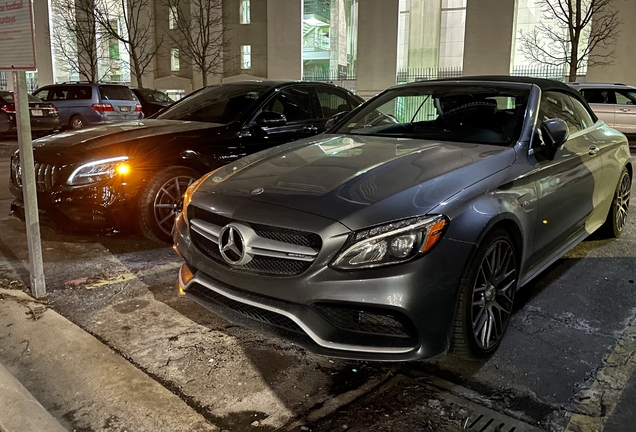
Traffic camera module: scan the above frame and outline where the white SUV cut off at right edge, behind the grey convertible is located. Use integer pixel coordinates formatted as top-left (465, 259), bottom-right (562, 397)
top-left (570, 83), bottom-right (636, 140)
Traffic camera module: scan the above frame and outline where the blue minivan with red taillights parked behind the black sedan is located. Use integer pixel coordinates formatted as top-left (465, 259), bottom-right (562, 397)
top-left (33, 82), bottom-right (144, 129)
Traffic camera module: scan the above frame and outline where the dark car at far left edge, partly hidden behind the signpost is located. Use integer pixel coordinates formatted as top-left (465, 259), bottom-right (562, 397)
top-left (0, 91), bottom-right (61, 137)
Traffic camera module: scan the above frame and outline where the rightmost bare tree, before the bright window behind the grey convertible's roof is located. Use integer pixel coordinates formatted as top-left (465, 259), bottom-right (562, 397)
top-left (520, 0), bottom-right (621, 81)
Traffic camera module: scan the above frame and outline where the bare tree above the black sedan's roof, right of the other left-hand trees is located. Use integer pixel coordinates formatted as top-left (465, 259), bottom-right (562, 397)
top-left (163, 0), bottom-right (225, 87)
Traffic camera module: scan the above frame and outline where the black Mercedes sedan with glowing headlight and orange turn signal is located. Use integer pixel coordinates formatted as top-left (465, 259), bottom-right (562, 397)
top-left (10, 81), bottom-right (362, 241)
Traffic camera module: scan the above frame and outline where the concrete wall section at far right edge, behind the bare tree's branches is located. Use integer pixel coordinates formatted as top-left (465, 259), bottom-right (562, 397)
top-left (586, 0), bottom-right (636, 85)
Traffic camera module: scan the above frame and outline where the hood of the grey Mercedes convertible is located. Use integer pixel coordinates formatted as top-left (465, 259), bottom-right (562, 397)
top-left (197, 135), bottom-right (516, 229)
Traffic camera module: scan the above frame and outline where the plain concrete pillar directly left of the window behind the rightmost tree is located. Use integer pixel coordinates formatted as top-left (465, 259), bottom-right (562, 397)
top-left (463, 0), bottom-right (516, 76)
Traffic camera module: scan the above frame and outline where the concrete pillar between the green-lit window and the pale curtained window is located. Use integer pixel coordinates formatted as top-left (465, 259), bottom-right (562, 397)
top-left (356, 0), bottom-right (398, 98)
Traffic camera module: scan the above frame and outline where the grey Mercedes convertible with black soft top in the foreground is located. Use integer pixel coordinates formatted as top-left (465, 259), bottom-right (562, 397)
top-left (174, 77), bottom-right (633, 360)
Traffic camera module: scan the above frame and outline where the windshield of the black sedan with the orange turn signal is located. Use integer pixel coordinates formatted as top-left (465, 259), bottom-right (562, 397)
top-left (157, 85), bottom-right (270, 124)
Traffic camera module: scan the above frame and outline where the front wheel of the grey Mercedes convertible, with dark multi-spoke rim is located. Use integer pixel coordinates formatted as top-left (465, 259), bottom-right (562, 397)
top-left (450, 229), bottom-right (519, 358)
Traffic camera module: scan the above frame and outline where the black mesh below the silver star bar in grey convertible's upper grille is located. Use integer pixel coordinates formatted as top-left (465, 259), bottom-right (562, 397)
top-left (190, 230), bottom-right (312, 276)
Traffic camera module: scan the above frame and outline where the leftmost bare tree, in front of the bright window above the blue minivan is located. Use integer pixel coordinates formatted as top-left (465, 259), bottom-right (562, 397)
top-left (49, 0), bottom-right (101, 82)
